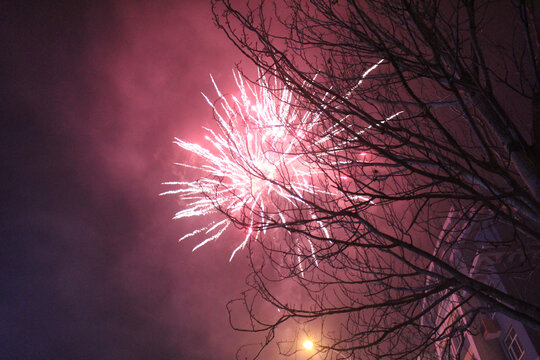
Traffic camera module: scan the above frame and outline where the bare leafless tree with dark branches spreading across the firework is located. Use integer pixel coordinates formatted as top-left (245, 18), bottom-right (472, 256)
top-left (189, 0), bottom-right (540, 359)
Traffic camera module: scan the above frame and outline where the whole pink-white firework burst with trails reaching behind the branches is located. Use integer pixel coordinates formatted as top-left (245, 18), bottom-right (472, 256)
top-left (160, 60), bottom-right (399, 262)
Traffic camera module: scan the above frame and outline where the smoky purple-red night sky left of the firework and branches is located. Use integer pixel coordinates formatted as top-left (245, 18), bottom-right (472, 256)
top-left (0, 0), bottom-right (258, 359)
